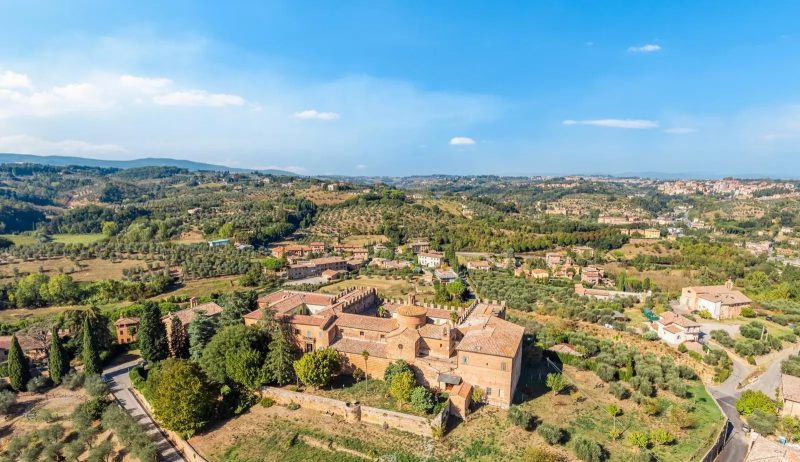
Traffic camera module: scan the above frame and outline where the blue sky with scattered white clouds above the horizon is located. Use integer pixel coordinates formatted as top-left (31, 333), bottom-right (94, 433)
top-left (0, 0), bottom-right (800, 176)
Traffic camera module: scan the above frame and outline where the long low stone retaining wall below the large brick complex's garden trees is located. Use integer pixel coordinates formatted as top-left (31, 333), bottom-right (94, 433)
top-left (261, 387), bottom-right (450, 437)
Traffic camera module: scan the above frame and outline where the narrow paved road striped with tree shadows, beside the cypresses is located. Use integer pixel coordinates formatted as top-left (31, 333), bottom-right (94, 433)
top-left (103, 359), bottom-right (186, 462)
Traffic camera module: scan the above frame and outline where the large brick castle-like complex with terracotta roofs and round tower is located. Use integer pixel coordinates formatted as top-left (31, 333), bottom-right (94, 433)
top-left (244, 289), bottom-right (524, 408)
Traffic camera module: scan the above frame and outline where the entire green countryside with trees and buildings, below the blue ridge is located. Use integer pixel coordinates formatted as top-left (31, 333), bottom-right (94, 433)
top-left (0, 164), bottom-right (800, 461)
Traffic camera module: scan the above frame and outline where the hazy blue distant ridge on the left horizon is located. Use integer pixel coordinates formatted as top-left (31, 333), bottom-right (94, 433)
top-left (0, 153), bottom-right (297, 176)
